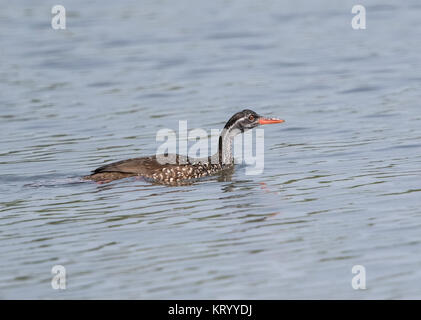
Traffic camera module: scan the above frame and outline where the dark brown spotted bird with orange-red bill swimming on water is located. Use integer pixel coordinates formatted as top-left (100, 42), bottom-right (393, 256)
top-left (83, 109), bottom-right (284, 185)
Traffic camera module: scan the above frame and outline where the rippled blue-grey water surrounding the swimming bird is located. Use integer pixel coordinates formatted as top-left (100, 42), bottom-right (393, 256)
top-left (0, 0), bottom-right (421, 299)
